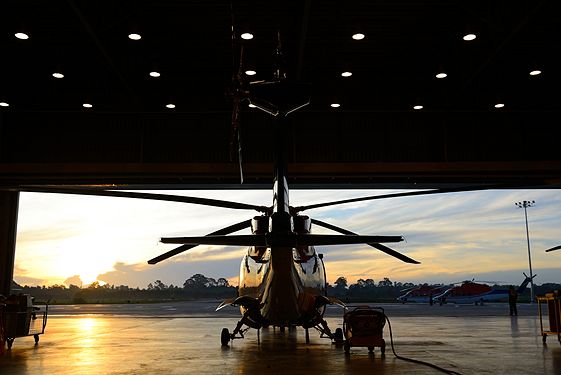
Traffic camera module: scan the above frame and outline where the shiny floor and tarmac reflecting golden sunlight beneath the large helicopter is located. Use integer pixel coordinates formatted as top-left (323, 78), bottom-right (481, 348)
top-left (0, 301), bottom-right (561, 375)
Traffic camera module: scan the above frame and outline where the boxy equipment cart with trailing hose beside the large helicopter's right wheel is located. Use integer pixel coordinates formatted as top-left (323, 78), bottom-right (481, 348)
top-left (343, 305), bottom-right (386, 355)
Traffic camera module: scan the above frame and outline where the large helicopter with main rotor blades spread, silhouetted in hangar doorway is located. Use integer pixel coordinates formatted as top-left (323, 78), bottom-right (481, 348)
top-left (20, 160), bottom-right (504, 346)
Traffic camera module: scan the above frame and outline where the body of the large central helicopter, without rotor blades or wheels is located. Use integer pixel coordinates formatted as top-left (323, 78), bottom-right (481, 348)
top-left (233, 129), bottom-right (329, 327)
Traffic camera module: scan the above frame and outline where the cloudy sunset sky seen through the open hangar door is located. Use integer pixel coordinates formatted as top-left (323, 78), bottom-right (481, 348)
top-left (14, 189), bottom-right (561, 288)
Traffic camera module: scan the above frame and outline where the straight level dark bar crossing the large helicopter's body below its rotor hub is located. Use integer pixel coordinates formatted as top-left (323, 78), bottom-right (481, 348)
top-left (160, 234), bottom-right (403, 247)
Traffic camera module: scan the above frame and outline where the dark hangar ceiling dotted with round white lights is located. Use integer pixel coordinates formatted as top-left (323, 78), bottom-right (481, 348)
top-left (0, 0), bottom-right (561, 188)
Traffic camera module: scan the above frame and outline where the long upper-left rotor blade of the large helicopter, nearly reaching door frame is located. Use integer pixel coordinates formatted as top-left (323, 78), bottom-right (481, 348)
top-left (18, 187), bottom-right (269, 212)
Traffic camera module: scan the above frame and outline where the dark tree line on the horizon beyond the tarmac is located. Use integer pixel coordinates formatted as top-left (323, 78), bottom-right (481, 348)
top-left (12, 274), bottom-right (561, 304)
